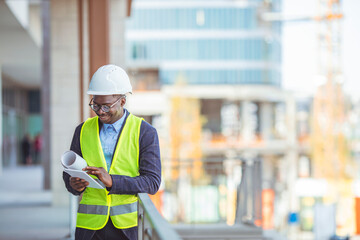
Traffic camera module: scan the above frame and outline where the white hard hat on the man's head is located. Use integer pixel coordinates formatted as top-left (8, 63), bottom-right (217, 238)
top-left (87, 64), bottom-right (132, 95)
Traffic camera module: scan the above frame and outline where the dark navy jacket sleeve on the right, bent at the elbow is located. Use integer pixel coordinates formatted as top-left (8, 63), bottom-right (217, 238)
top-left (108, 121), bottom-right (161, 194)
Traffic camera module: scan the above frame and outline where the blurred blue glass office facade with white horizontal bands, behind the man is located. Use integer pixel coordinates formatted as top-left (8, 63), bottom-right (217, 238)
top-left (126, 0), bottom-right (281, 86)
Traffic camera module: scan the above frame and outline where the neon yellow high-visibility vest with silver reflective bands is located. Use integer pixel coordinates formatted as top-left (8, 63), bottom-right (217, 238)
top-left (76, 114), bottom-right (142, 230)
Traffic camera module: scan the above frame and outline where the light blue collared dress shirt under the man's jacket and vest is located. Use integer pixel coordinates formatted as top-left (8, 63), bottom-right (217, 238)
top-left (100, 111), bottom-right (126, 172)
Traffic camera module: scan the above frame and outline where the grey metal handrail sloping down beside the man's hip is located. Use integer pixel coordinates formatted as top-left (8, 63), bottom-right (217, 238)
top-left (138, 193), bottom-right (181, 240)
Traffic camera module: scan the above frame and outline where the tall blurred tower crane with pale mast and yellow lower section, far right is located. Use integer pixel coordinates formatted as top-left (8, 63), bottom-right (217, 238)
top-left (312, 0), bottom-right (348, 179)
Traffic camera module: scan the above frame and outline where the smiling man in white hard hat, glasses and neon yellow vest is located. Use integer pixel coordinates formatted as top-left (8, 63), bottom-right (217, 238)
top-left (63, 65), bottom-right (161, 240)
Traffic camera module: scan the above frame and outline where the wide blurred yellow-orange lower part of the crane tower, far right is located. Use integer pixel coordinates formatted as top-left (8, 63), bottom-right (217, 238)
top-left (312, 82), bottom-right (349, 179)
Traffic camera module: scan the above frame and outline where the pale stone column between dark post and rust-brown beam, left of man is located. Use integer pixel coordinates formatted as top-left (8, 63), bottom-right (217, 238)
top-left (50, 0), bottom-right (80, 206)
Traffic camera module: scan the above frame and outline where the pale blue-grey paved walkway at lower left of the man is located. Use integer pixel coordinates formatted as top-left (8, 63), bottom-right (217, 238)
top-left (0, 166), bottom-right (69, 240)
